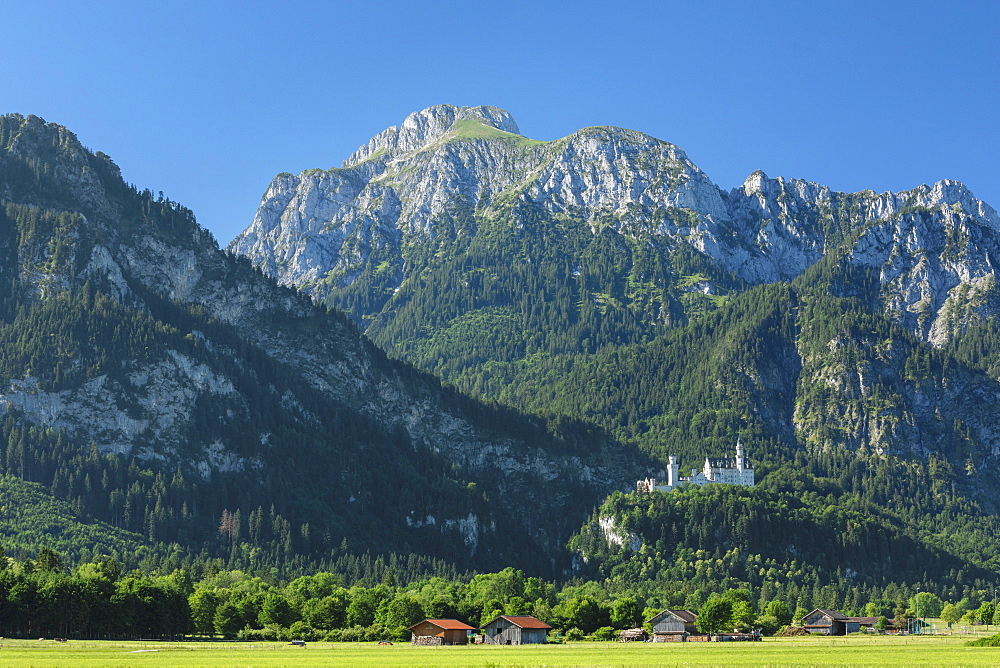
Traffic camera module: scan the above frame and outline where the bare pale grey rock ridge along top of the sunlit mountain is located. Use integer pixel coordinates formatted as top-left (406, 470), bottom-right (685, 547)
top-left (229, 105), bottom-right (1000, 344)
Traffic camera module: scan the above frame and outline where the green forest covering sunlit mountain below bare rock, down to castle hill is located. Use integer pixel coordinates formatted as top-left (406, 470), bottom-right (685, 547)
top-left (316, 185), bottom-right (1000, 594)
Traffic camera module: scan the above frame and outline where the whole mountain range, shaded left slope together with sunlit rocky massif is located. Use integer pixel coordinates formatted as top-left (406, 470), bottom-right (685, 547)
top-left (0, 105), bottom-right (1000, 593)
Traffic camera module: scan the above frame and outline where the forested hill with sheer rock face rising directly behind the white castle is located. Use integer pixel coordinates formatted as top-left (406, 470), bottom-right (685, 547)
top-left (470, 254), bottom-right (1000, 486)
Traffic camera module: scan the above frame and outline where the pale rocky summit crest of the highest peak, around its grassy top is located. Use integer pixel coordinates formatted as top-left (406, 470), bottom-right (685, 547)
top-left (343, 104), bottom-right (521, 168)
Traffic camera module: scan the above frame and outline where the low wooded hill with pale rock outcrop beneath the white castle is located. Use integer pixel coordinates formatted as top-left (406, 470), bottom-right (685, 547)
top-left (571, 451), bottom-right (1000, 596)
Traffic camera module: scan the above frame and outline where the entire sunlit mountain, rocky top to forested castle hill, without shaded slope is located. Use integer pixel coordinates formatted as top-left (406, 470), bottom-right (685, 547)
top-left (231, 105), bottom-right (1000, 594)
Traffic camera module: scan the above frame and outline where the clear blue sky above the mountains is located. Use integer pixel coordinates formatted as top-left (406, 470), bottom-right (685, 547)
top-left (0, 0), bottom-right (1000, 244)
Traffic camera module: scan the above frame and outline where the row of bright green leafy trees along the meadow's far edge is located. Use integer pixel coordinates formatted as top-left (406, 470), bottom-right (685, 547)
top-left (0, 548), bottom-right (1000, 641)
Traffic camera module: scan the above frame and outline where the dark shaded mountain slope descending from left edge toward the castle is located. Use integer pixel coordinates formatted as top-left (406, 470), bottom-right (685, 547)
top-left (0, 115), bottom-right (637, 566)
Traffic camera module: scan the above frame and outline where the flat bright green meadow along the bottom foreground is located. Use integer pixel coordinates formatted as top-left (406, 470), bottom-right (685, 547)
top-left (0, 636), bottom-right (1000, 668)
